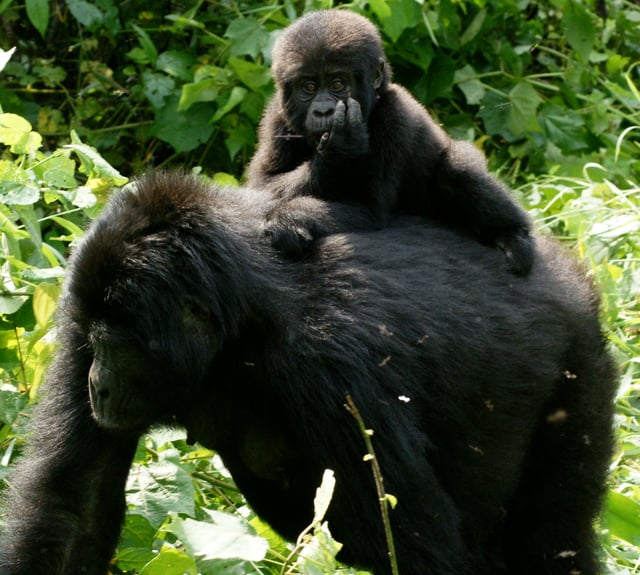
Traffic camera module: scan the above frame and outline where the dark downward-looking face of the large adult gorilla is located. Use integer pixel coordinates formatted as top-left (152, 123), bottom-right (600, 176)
top-left (88, 294), bottom-right (215, 433)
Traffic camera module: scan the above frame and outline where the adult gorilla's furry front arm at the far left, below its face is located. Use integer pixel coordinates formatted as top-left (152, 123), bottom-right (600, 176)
top-left (0, 320), bottom-right (137, 575)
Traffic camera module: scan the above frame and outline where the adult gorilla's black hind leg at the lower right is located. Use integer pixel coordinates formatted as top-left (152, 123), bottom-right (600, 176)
top-left (505, 342), bottom-right (614, 575)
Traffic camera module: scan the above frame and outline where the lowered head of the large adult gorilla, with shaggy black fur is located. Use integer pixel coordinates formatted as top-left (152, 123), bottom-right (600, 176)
top-left (68, 174), bottom-right (260, 433)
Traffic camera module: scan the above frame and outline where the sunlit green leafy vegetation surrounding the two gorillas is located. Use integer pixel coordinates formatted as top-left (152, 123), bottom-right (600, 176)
top-left (0, 0), bottom-right (640, 575)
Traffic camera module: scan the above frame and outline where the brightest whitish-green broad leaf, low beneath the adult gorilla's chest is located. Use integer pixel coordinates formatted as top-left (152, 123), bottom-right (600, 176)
top-left (168, 509), bottom-right (269, 561)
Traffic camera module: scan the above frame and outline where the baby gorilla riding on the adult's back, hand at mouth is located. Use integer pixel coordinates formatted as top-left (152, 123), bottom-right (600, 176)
top-left (248, 9), bottom-right (533, 274)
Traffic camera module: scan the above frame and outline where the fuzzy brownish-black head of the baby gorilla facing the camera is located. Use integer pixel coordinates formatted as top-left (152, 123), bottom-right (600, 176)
top-left (271, 10), bottom-right (391, 143)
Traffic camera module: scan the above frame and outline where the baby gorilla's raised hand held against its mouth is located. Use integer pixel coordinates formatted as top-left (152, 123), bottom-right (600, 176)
top-left (317, 98), bottom-right (369, 159)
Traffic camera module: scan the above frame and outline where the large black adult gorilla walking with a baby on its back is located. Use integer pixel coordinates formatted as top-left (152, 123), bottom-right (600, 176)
top-left (0, 174), bottom-right (615, 575)
